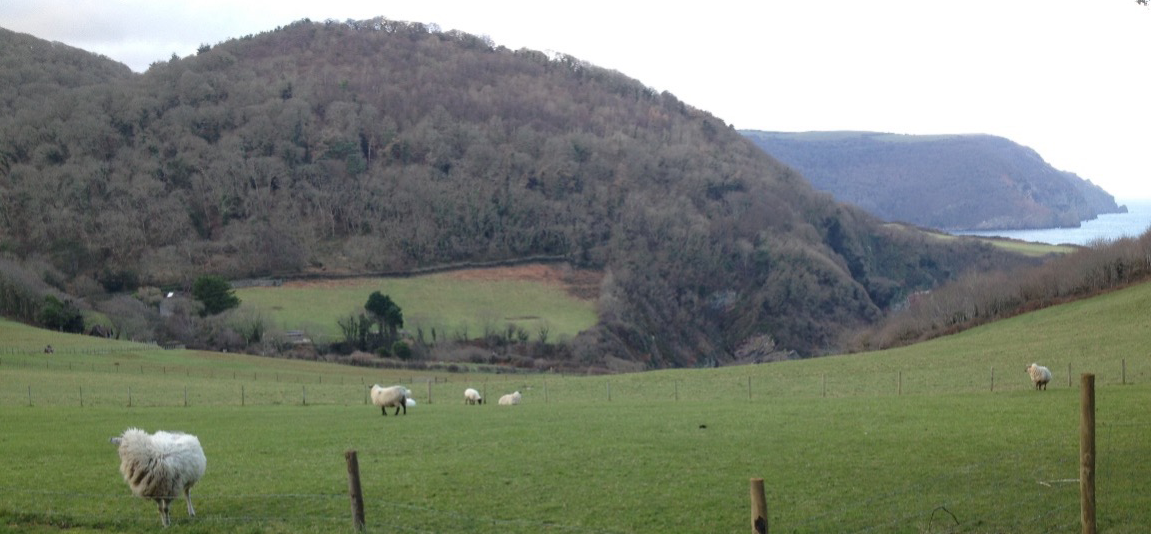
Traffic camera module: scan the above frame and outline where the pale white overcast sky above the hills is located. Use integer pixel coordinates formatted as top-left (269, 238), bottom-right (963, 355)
top-left (0, 0), bottom-right (1151, 203)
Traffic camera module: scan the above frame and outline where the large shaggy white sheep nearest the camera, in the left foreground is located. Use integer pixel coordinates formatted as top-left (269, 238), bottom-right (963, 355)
top-left (110, 428), bottom-right (208, 527)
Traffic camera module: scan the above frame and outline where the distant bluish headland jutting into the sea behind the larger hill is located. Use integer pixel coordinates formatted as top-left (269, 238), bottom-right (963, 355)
top-left (744, 131), bottom-right (1126, 230)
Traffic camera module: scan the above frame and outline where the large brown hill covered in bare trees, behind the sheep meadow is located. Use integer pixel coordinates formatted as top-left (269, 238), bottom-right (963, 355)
top-left (0, 18), bottom-right (1031, 367)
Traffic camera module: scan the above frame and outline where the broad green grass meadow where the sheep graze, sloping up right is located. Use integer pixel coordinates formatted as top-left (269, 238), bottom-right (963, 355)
top-left (0, 284), bottom-right (1151, 533)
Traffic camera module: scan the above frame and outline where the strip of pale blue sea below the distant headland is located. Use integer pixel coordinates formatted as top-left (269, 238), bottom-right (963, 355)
top-left (955, 200), bottom-right (1151, 245)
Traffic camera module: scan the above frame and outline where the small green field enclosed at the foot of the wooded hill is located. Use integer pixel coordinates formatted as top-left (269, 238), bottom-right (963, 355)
top-left (236, 273), bottom-right (596, 341)
